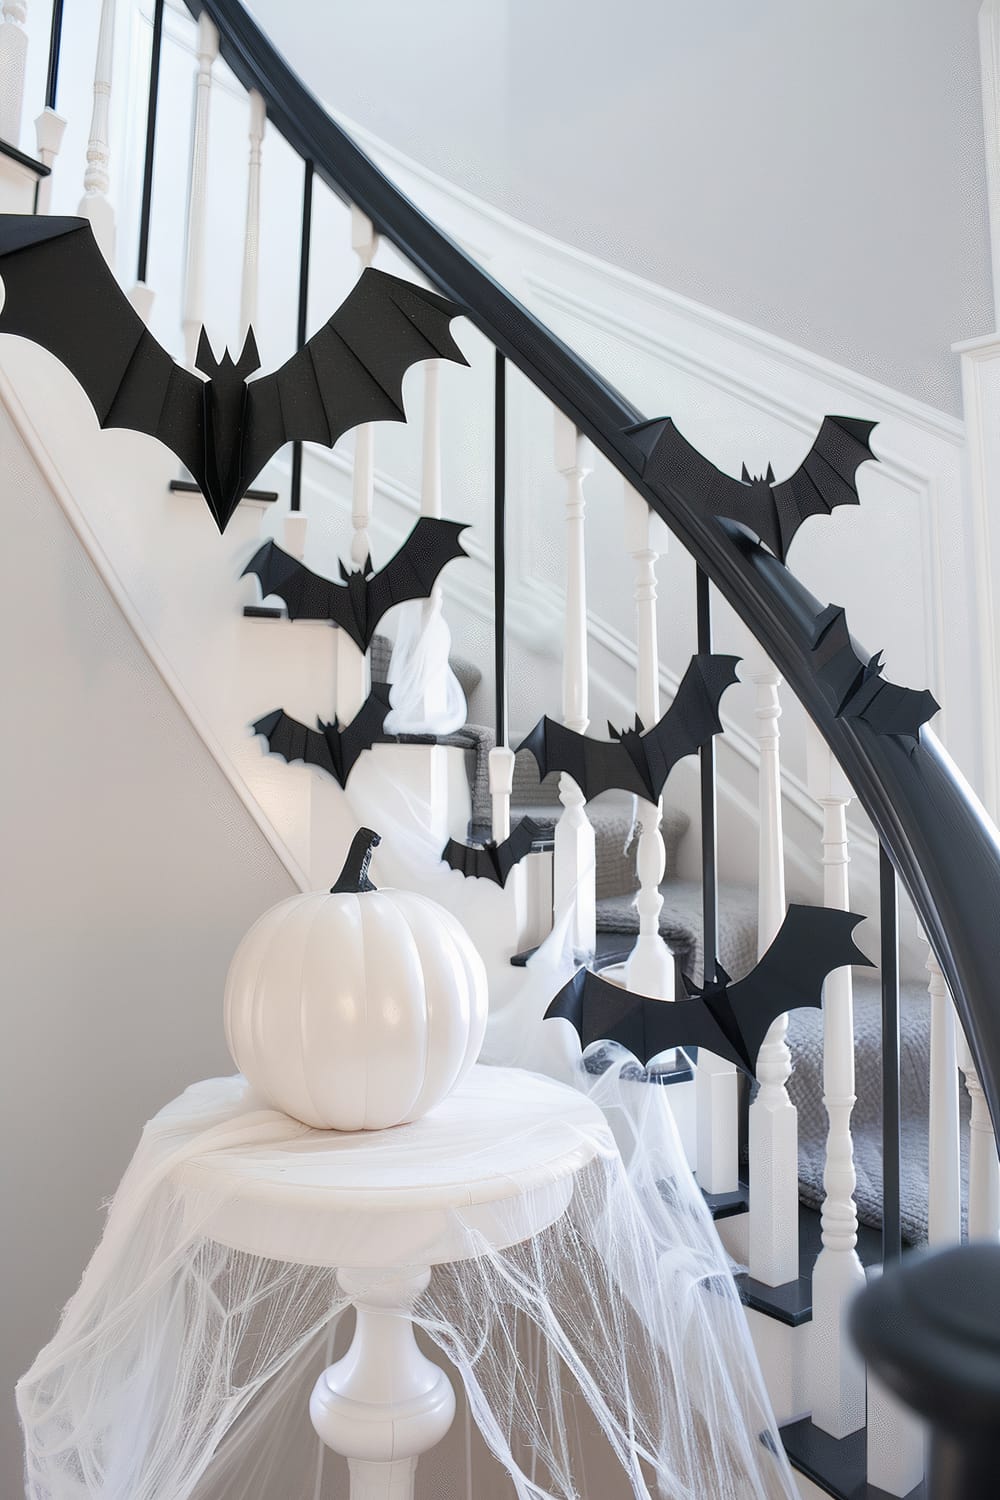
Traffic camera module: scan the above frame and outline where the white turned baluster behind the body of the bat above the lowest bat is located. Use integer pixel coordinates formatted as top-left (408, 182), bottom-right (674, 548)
top-left (625, 485), bottom-right (675, 1001)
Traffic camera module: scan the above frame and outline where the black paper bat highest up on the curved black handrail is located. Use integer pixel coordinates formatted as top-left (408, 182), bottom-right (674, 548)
top-left (628, 417), bottom-right (877, 563)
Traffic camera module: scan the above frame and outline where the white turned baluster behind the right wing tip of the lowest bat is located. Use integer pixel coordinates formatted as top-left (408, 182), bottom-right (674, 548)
top-left (808, 725), bottom-right (865, 1439)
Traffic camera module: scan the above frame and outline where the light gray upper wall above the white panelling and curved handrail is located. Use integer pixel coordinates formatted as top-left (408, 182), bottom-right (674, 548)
top-left (252, 0), bottom-right (993, 411)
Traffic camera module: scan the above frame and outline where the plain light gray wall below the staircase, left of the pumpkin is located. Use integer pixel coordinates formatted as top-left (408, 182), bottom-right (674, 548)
top-left (0, 413), bottom-right (292, 1500)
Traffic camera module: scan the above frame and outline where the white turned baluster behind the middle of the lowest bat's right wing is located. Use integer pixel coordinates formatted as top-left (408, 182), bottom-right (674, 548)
top-left (750, 663), bottom-right (799, 1287)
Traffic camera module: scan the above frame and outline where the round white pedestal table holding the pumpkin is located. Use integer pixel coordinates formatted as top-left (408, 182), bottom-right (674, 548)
top-left (175, 1067), bottom-right (615, 1500)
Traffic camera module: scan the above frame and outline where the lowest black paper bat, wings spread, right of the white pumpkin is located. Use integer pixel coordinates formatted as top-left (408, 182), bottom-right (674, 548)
top-left (546, 906), bottom-right (871, 1079)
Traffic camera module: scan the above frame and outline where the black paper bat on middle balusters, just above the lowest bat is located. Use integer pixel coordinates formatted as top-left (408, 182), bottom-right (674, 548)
top-left (517, 653), bottom-right (739, 803)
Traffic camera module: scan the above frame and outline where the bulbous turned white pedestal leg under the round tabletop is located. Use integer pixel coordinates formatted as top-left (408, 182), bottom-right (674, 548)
top-left (309, 1268), bottom-right (454, 1500)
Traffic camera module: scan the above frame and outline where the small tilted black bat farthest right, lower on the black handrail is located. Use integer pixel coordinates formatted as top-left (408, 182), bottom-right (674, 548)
top-left (811, 605), bottom-right (940, 755)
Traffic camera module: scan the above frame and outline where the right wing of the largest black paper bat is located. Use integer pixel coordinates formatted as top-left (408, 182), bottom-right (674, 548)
top-left (244, 269), bottom-right (468, 485)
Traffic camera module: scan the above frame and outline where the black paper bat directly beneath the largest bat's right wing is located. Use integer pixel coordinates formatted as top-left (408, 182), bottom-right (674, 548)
top-left (243, 516), bottom-right (468, 651)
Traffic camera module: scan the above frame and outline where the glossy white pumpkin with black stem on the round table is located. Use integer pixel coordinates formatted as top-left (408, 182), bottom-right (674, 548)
top-left (225, 828), bottom-right (487, 1131)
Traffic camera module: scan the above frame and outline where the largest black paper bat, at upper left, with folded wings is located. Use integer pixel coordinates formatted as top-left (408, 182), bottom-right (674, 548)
top-left (0, 215), bottom-right (466, 531)
